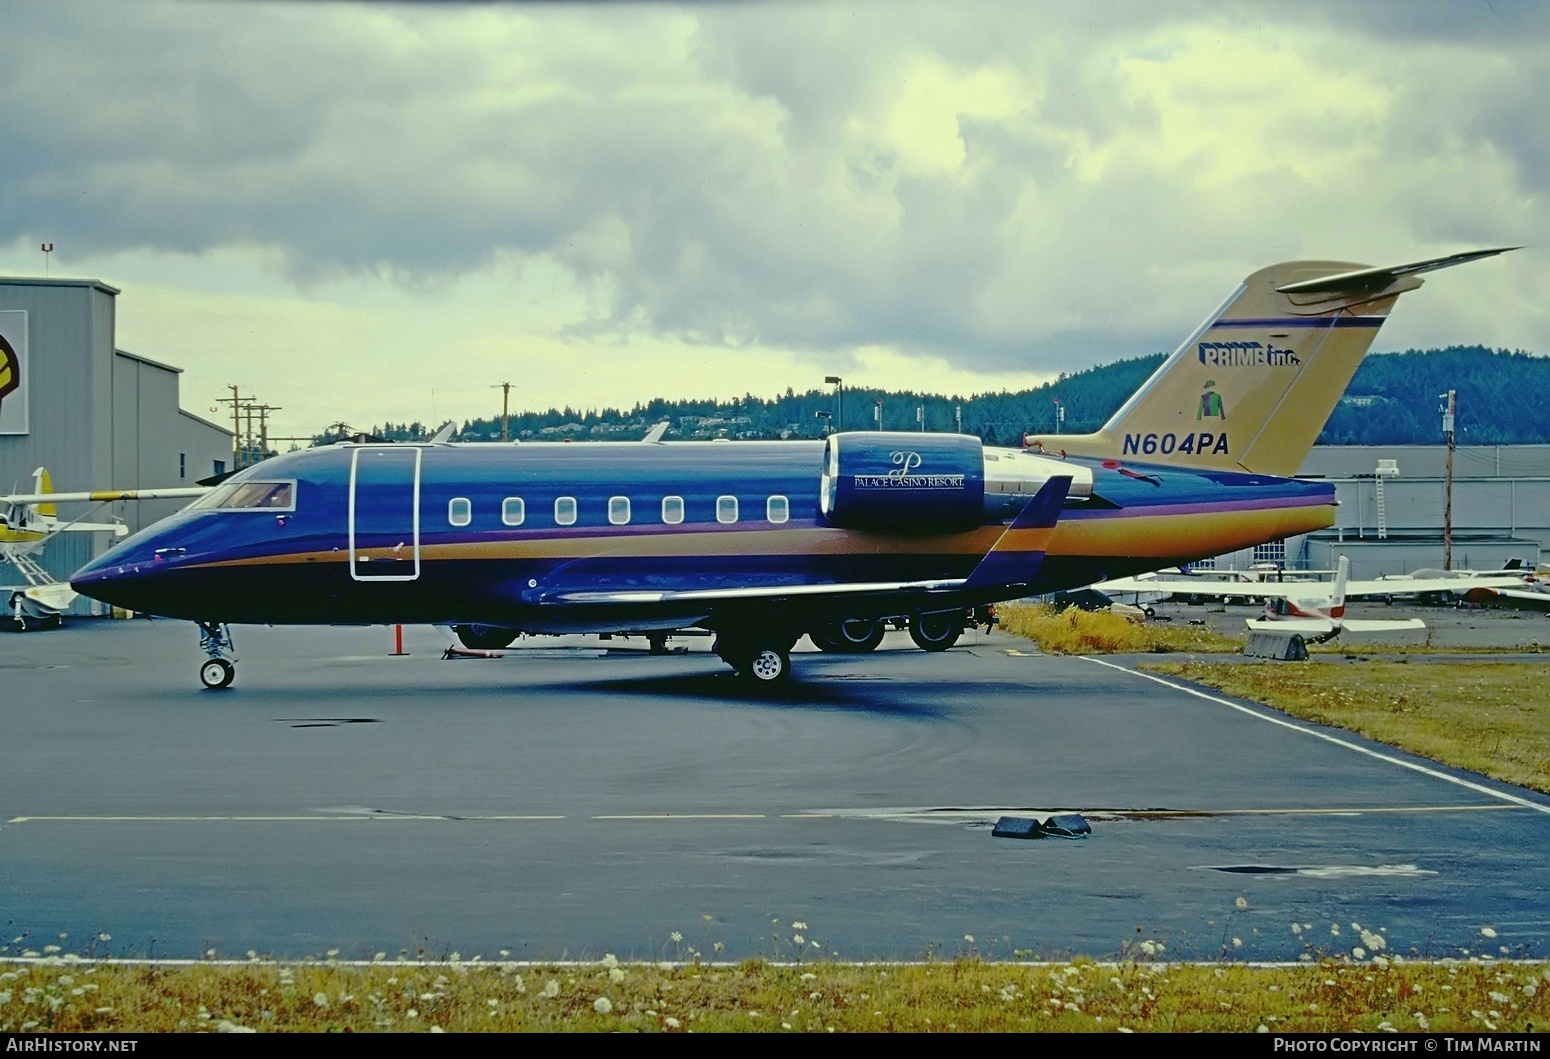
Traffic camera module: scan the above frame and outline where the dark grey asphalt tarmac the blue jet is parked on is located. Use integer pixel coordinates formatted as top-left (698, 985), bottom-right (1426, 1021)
top-left (0, 608), bottom-right (1550, 960)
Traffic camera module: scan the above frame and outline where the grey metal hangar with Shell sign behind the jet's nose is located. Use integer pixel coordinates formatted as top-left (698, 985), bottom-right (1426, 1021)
top-left (0, 278), bottom-right (233, 611)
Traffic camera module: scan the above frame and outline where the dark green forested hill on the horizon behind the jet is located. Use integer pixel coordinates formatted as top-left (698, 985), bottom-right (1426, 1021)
top-left (339, 346), bottom-right (1550, 445)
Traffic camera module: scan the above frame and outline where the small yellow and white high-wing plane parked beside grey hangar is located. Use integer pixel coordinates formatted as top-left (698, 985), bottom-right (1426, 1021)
top-left (0, 467), bottom-right (209, 633)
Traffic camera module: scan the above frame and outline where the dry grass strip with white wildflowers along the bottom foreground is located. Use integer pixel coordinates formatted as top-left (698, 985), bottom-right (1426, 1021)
top-left (0, 954), bottom-right (1550, 1033)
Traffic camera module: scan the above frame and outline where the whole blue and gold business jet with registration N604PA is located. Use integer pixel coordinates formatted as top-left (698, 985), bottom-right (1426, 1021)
top-left (71, 248), bottom-right (1507, 688)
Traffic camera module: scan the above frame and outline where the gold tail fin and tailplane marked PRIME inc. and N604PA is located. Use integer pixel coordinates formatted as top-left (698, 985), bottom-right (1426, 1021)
top-left (1029, 247), bottom-right (1514, 474)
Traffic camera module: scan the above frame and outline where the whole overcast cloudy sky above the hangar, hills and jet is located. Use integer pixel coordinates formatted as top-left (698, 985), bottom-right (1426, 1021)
top-left (0, 0), bottom-right (1550, 434)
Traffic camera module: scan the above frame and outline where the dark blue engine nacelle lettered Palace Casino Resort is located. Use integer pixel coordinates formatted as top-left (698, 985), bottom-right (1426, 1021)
top-left (818, 431), bottom-right (984, 532)
